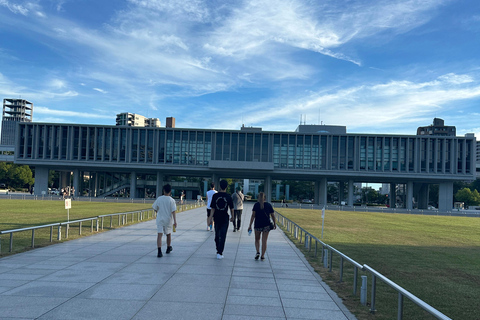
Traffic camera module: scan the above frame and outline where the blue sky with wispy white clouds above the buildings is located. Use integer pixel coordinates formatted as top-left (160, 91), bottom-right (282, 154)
top-left (0, 0), bottom-right (480, 137)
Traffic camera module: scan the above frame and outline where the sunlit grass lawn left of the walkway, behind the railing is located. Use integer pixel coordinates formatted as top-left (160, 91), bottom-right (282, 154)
top-left (0, 199), bottom-right (151, 256)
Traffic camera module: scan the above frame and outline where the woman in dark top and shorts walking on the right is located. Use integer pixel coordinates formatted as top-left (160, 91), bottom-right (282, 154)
top-left (248, 192), bottom-right (277, 260)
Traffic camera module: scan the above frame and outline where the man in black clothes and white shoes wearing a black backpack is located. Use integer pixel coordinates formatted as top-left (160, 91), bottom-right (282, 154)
top-left (208, 180), bottom-right (233, 259)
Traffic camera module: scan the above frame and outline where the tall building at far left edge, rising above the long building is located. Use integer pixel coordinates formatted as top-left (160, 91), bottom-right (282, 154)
top-left (0, 99), bottom-right (33, 146)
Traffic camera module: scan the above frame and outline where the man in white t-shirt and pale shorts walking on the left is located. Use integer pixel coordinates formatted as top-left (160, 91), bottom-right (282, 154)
top-left (152, 184), bottom-right (177, 258)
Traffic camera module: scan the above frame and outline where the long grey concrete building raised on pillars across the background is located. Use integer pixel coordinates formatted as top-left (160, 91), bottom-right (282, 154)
top-left (15, 123), bottom-right (476, 211)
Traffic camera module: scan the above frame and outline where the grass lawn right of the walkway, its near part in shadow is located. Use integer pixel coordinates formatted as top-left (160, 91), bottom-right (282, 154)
top-left (276, 208), bottom-right (480, 320)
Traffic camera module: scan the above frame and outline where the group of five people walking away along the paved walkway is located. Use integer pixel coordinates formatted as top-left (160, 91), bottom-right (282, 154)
top-left (152, 180), bottom-right (277, 260)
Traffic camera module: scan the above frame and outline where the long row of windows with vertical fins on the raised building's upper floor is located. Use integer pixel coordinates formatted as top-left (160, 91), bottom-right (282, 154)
top-left (16, 123), bottom-right (475, 174)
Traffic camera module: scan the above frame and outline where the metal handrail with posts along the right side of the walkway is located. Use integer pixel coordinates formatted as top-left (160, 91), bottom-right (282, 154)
top-left (275, 211), bottom-right (452, 320)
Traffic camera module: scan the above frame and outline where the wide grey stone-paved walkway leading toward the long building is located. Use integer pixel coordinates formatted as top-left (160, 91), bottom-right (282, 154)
top-left (0, 204), bottom-right (355, 320)
